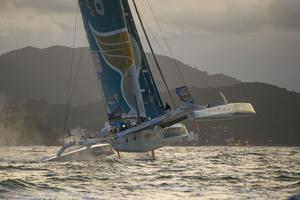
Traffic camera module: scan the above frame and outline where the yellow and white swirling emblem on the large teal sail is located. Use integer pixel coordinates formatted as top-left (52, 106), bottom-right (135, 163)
top-left (89, 24), bottom-right (145, 116)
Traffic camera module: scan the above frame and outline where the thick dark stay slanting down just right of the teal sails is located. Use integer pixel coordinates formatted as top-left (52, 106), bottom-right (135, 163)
top-left (132, 0), bottom-right (176, 108)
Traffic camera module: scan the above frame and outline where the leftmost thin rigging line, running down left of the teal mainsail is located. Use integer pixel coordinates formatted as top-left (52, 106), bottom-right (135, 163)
top-left (63, 4), bottom-right (78, 133)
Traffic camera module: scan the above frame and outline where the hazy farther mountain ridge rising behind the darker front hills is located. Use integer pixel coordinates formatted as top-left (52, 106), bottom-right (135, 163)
top-left (0, 46), bottom-right (241, 104)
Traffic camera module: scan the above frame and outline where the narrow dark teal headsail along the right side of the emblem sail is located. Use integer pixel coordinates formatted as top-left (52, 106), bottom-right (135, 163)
top-left (122, 0), bottom-right (164, 119)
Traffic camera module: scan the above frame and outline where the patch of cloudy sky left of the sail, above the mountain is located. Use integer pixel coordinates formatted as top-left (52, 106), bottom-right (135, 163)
top-left (0, 0), bottom-right (85, 53)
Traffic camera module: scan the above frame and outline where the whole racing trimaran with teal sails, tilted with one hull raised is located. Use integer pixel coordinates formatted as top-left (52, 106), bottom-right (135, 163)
top-left (47, 0), bottom-right (255, 161)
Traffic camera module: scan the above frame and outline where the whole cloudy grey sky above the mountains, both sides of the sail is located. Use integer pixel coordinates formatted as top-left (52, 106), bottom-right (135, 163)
top-left (0, 0), bottom-right (300, 92)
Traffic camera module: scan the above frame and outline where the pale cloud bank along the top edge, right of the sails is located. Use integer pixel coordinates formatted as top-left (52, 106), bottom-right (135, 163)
top-left (137, 0), bottom-right (300, 35)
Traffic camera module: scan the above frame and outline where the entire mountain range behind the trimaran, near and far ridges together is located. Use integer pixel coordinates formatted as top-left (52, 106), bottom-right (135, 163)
top-left (0, 46), bottom-right (300, 146)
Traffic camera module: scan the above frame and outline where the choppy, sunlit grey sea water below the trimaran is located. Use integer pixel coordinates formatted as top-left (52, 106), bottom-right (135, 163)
top-left (0, 147), bottom-right (300, 200)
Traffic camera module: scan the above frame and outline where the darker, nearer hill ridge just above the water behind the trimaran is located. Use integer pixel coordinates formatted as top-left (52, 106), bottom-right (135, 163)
top-left (0, 82), bottom-right (300, 146)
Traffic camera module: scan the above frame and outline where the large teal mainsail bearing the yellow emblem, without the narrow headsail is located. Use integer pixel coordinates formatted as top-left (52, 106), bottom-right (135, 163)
top-left (78, 0), bottom-right (146, 121)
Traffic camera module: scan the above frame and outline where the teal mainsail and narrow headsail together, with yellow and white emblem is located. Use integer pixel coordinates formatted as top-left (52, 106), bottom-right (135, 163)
top-left (78, 0), bottom-right (163, 121)
